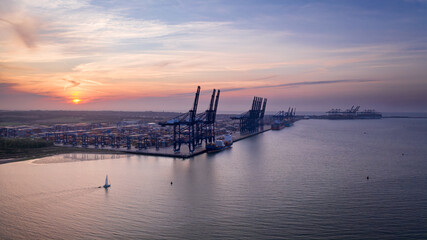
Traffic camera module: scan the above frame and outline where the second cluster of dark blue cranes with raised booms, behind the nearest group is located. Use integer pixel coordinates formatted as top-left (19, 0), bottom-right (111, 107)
top-left (231, 97), bottom-right (267, 134)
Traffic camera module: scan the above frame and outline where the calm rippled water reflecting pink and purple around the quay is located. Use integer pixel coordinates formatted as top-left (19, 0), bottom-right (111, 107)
top-left (0, 119), bottom-right (427, 239)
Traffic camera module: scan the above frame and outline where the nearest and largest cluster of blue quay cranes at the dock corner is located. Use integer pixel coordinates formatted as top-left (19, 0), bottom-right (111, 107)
top-left (159, 86), bottom-right (220, 153)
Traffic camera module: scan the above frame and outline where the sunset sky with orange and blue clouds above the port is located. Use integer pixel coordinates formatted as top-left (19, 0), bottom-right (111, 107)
top-left (0, 0), bottom-right (427, 112)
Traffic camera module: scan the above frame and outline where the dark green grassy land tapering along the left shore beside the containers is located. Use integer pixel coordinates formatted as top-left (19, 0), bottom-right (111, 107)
top-left (0, 138), bottom-right (117, 164)
